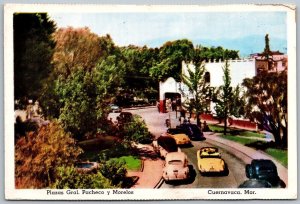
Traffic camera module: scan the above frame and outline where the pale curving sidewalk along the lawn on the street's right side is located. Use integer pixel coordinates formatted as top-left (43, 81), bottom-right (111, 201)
top-left (204, 132), bottom-right (288, 186)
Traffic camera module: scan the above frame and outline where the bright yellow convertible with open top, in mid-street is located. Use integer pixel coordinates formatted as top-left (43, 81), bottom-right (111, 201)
top-left (197, 147), bottom-right (228, 175)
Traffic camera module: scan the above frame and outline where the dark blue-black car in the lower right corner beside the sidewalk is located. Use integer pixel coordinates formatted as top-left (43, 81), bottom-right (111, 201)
top-left (245, 159), bottom-right (282, 187)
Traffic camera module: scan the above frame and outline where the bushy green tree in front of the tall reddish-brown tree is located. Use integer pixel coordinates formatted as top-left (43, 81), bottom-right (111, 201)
top-left (54, 50), bottom-right (124, 139)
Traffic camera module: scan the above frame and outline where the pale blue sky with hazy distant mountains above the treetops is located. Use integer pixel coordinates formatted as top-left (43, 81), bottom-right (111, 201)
top-left (48, 11), bottom-right (287, 55)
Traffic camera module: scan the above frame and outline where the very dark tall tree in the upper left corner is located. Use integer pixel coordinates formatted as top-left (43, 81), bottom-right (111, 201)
top-left (13, 13), bottom-right (56, 104)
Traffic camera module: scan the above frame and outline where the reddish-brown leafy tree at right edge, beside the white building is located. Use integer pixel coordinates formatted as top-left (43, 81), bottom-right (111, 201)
top-left (242, 71), bottom-right (288, 147)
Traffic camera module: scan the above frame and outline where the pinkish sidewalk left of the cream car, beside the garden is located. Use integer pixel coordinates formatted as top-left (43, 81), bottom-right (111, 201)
top-left (127, 145), bottom-right (163, 188)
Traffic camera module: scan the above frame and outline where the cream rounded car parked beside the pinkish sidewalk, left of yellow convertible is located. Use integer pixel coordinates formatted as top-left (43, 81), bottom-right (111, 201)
top-left (163, 152), bottom-right (190, 182)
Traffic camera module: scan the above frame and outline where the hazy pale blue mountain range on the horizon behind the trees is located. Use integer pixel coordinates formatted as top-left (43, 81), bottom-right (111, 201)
top-left (145, 35), bottom-right (287, 57)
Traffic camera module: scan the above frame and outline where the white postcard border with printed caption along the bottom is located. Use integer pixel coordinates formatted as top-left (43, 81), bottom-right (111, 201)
top-left (4, 4), bottom-right (297, 200)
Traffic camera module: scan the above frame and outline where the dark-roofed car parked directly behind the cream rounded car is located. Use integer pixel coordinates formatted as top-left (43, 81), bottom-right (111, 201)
top-left (152, 135), bottom-right (181, 158)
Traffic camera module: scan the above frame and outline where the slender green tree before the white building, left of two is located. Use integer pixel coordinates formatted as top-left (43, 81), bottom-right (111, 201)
top-left (181, 63), bottom-right (211, 126)
